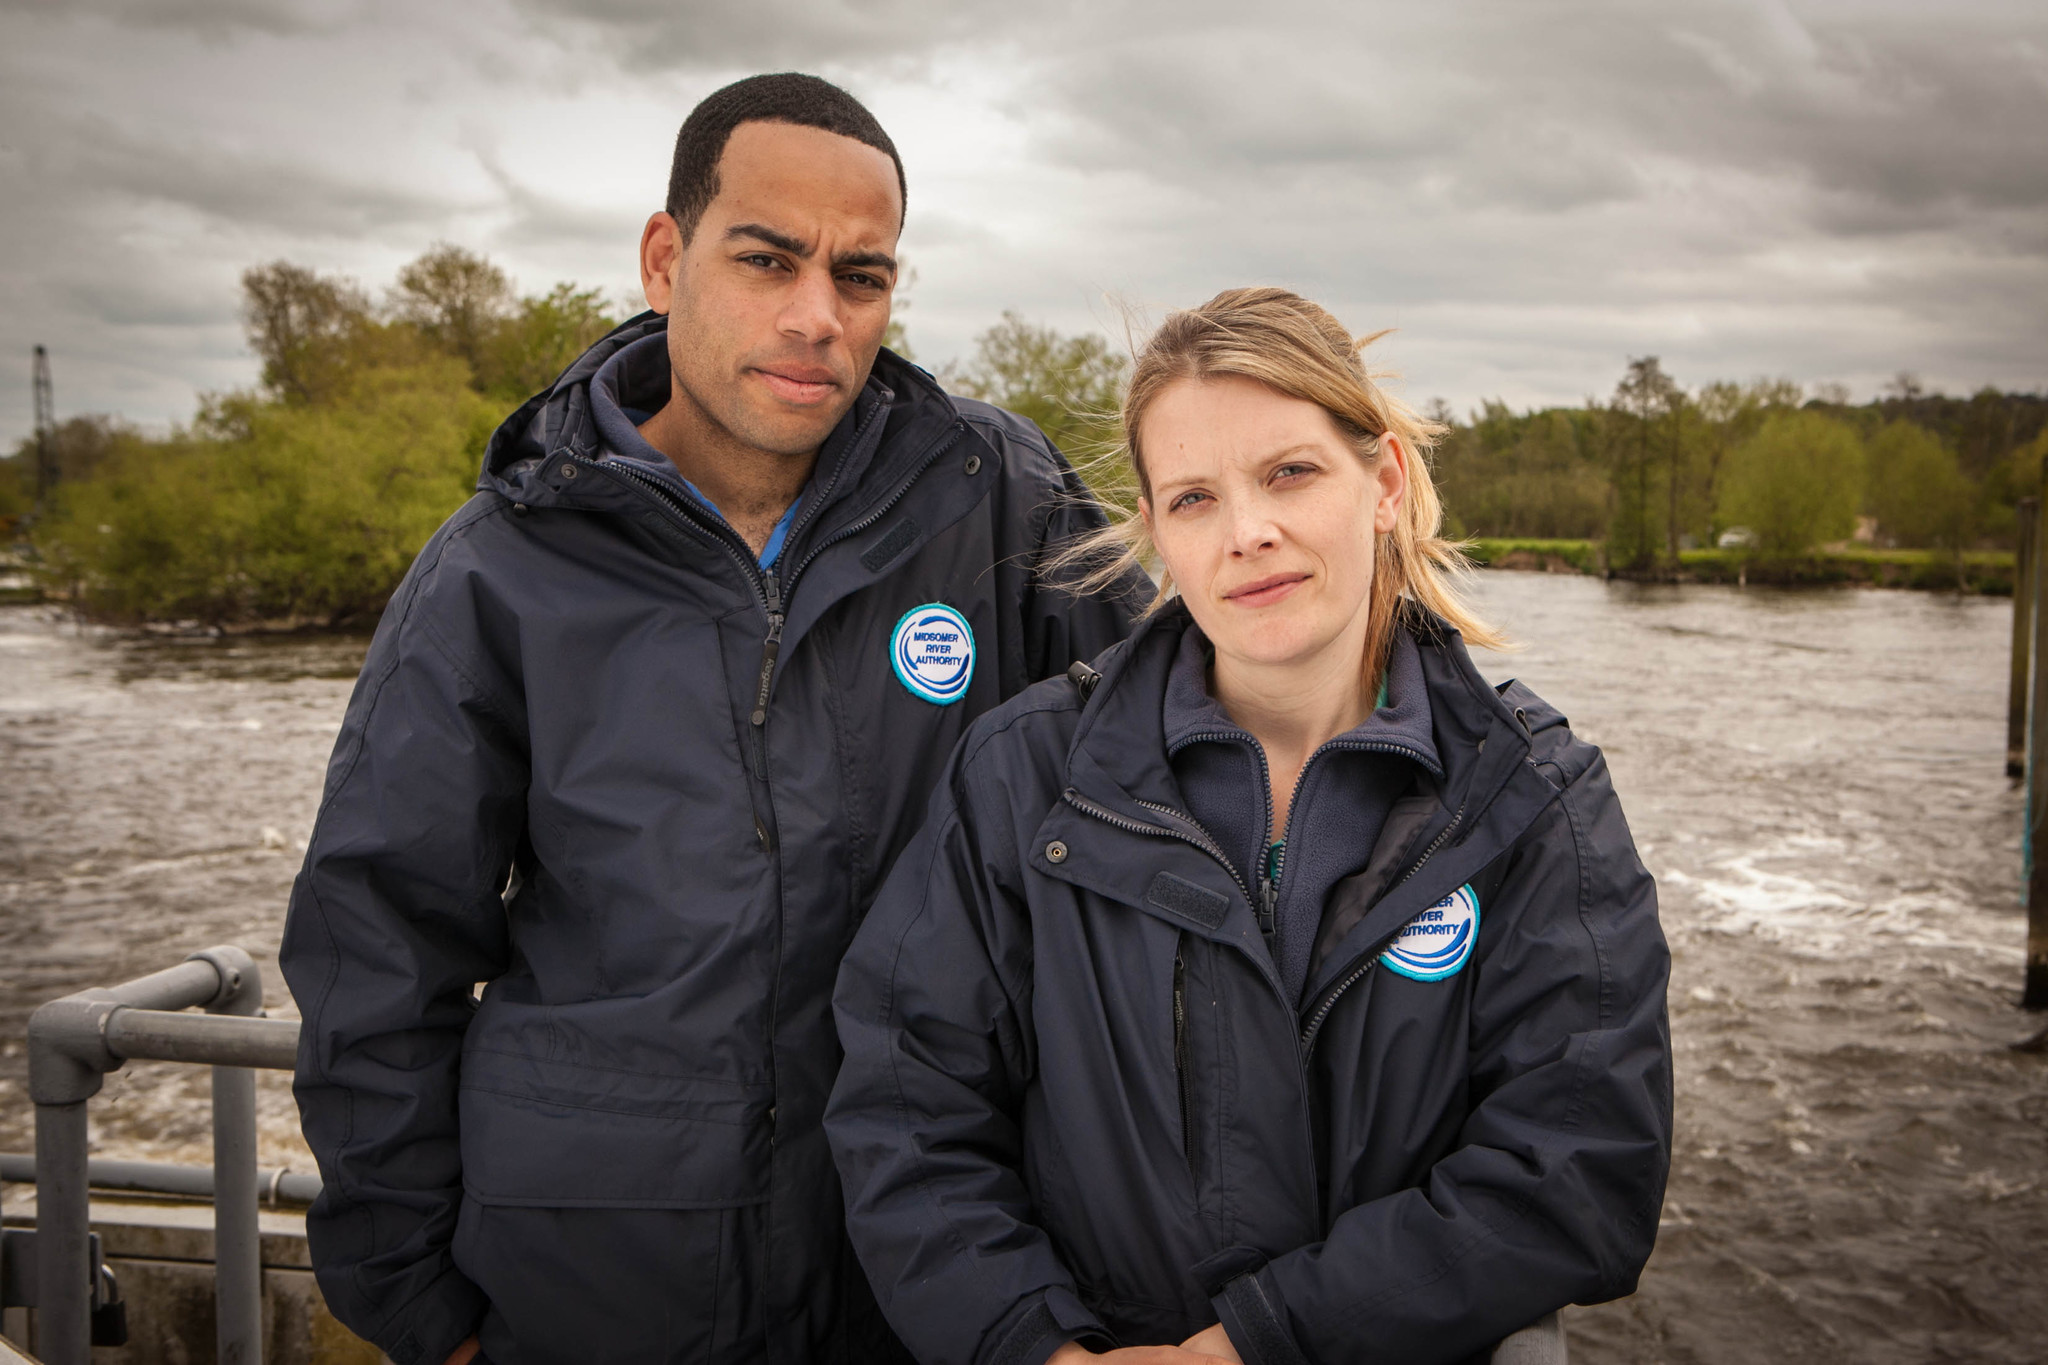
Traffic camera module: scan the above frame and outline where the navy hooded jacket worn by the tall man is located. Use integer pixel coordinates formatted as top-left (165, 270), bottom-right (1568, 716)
top-left (281, 315), bottom-right (1149, 1365)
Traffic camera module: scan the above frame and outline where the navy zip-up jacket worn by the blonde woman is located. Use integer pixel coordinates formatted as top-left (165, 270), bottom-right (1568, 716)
top-left (825, 610), bottom-right (1671, 1365)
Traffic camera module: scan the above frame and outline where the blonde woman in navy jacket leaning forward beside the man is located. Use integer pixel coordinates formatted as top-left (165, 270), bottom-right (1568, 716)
top-left (825, 289), bottom-right (1671, 1365)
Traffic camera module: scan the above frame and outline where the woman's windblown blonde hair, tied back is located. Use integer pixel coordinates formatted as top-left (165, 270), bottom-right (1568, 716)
top-left (1063, 289), bottom-right (1505, 684)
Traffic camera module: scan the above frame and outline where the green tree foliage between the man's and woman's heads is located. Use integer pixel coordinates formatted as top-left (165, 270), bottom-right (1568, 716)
top-left (940, 313), bottom-right (1137, 508)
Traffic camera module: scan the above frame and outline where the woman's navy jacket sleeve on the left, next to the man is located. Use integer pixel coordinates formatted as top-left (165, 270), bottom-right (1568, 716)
top-left (825, 737), bottom-right (1106, 1365)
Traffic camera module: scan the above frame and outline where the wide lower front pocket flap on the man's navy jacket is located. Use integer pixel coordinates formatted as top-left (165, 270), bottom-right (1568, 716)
top-left (459, 1007), bottom-right (774, 1209)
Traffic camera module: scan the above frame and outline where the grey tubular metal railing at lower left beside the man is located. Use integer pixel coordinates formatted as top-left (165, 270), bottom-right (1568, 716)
top-left (29, 948), bottom-right (299, 1365)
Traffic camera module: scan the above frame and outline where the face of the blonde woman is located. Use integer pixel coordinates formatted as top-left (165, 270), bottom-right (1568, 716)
top-left (1139, 375), bottom-right (1407, 667)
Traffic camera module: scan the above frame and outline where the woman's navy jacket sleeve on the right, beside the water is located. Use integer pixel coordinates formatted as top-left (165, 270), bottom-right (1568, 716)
top-left (1198, 755), bottom-right (1671, 1365)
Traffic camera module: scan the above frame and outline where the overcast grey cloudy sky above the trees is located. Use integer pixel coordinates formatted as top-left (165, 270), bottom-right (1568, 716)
top-left (0, 0), bottom-right (2048, 444)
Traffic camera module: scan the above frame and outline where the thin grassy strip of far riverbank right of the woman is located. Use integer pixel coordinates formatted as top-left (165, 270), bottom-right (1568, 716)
top-left (1468, 538), bottom-right (2013, 598)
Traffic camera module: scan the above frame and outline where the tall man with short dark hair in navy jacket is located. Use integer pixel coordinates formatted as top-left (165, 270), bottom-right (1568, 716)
top-left (281, 76), bottom-right (1139, 1365)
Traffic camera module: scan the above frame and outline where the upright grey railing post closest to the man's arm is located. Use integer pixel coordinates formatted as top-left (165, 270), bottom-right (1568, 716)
top-left (193, 948), bottom-right (262, 1365)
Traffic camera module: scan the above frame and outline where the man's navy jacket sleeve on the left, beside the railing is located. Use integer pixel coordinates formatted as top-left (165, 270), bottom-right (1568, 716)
top-left (279, 544), bottom-right (526, 1365)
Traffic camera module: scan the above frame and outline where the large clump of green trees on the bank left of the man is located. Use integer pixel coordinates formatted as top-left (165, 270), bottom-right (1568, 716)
top-left (28, 246), bottom-right (614, 624)
